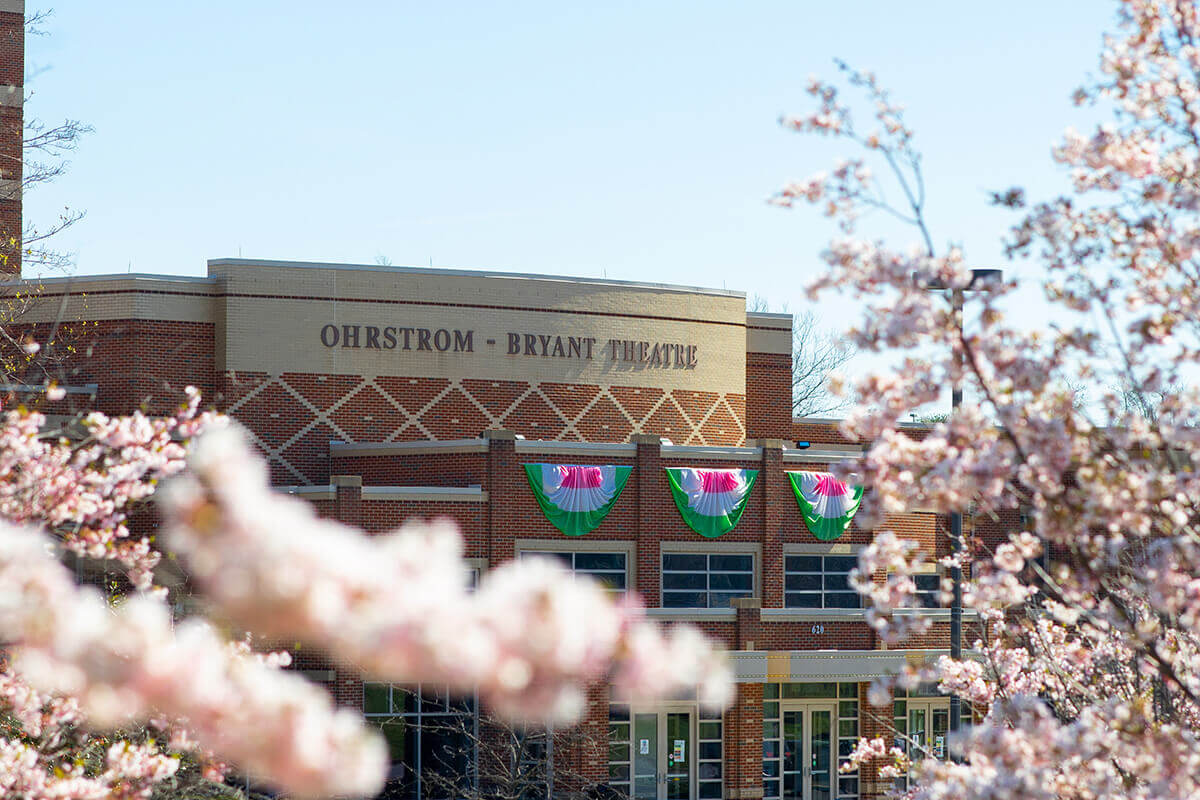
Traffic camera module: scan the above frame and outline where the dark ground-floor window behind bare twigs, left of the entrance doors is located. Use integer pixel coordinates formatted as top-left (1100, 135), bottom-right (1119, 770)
top-left (362, 682), bottom-right (479, 800)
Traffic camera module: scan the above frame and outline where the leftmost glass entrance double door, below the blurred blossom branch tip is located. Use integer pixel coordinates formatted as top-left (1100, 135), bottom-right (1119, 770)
top-left (632, 709), bottom-right (696, 800)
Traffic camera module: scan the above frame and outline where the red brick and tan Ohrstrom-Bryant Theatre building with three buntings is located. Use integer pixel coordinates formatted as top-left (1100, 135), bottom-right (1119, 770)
top-left (21, 259), bottom-right (982, 800)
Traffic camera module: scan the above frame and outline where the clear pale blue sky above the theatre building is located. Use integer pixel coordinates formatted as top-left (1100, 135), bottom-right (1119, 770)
top-left (26, 0), bottom-right (1115, 324)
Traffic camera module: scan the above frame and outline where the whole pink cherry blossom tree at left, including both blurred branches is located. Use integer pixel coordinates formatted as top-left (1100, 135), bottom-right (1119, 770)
top-left (0, 389), bottom-right (731, 799)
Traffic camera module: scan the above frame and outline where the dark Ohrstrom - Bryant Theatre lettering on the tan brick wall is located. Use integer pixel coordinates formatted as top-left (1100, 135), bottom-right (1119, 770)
top-left (320, 324), bottom-right (700, 369)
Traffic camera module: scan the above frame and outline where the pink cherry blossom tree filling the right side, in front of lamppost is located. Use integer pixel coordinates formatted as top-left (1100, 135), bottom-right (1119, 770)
top-left (774, 0), bottom-right (1200, 799)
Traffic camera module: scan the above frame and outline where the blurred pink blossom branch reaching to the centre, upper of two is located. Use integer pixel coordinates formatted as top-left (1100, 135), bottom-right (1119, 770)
top-left (163, 426), bottom-right (732, 720)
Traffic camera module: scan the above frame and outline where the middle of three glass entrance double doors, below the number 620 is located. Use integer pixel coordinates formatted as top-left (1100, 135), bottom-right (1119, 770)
top-left (782, 703), bottom-right (836, 800)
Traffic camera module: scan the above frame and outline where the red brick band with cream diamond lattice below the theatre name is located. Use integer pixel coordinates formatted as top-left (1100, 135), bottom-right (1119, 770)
top-left (221, 373), bottom-right (745, 485)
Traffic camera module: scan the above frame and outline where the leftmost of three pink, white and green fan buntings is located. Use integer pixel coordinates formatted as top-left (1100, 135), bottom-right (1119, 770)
top-left (524, 464), bottom-right (632, 536)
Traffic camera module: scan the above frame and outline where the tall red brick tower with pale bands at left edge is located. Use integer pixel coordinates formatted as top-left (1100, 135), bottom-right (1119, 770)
top-left (0, 0), bottom-right (25, 276)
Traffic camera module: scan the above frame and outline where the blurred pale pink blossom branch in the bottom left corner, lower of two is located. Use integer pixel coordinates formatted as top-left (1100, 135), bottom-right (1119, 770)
top-left (0, 525), bottom-right (386, 796)
